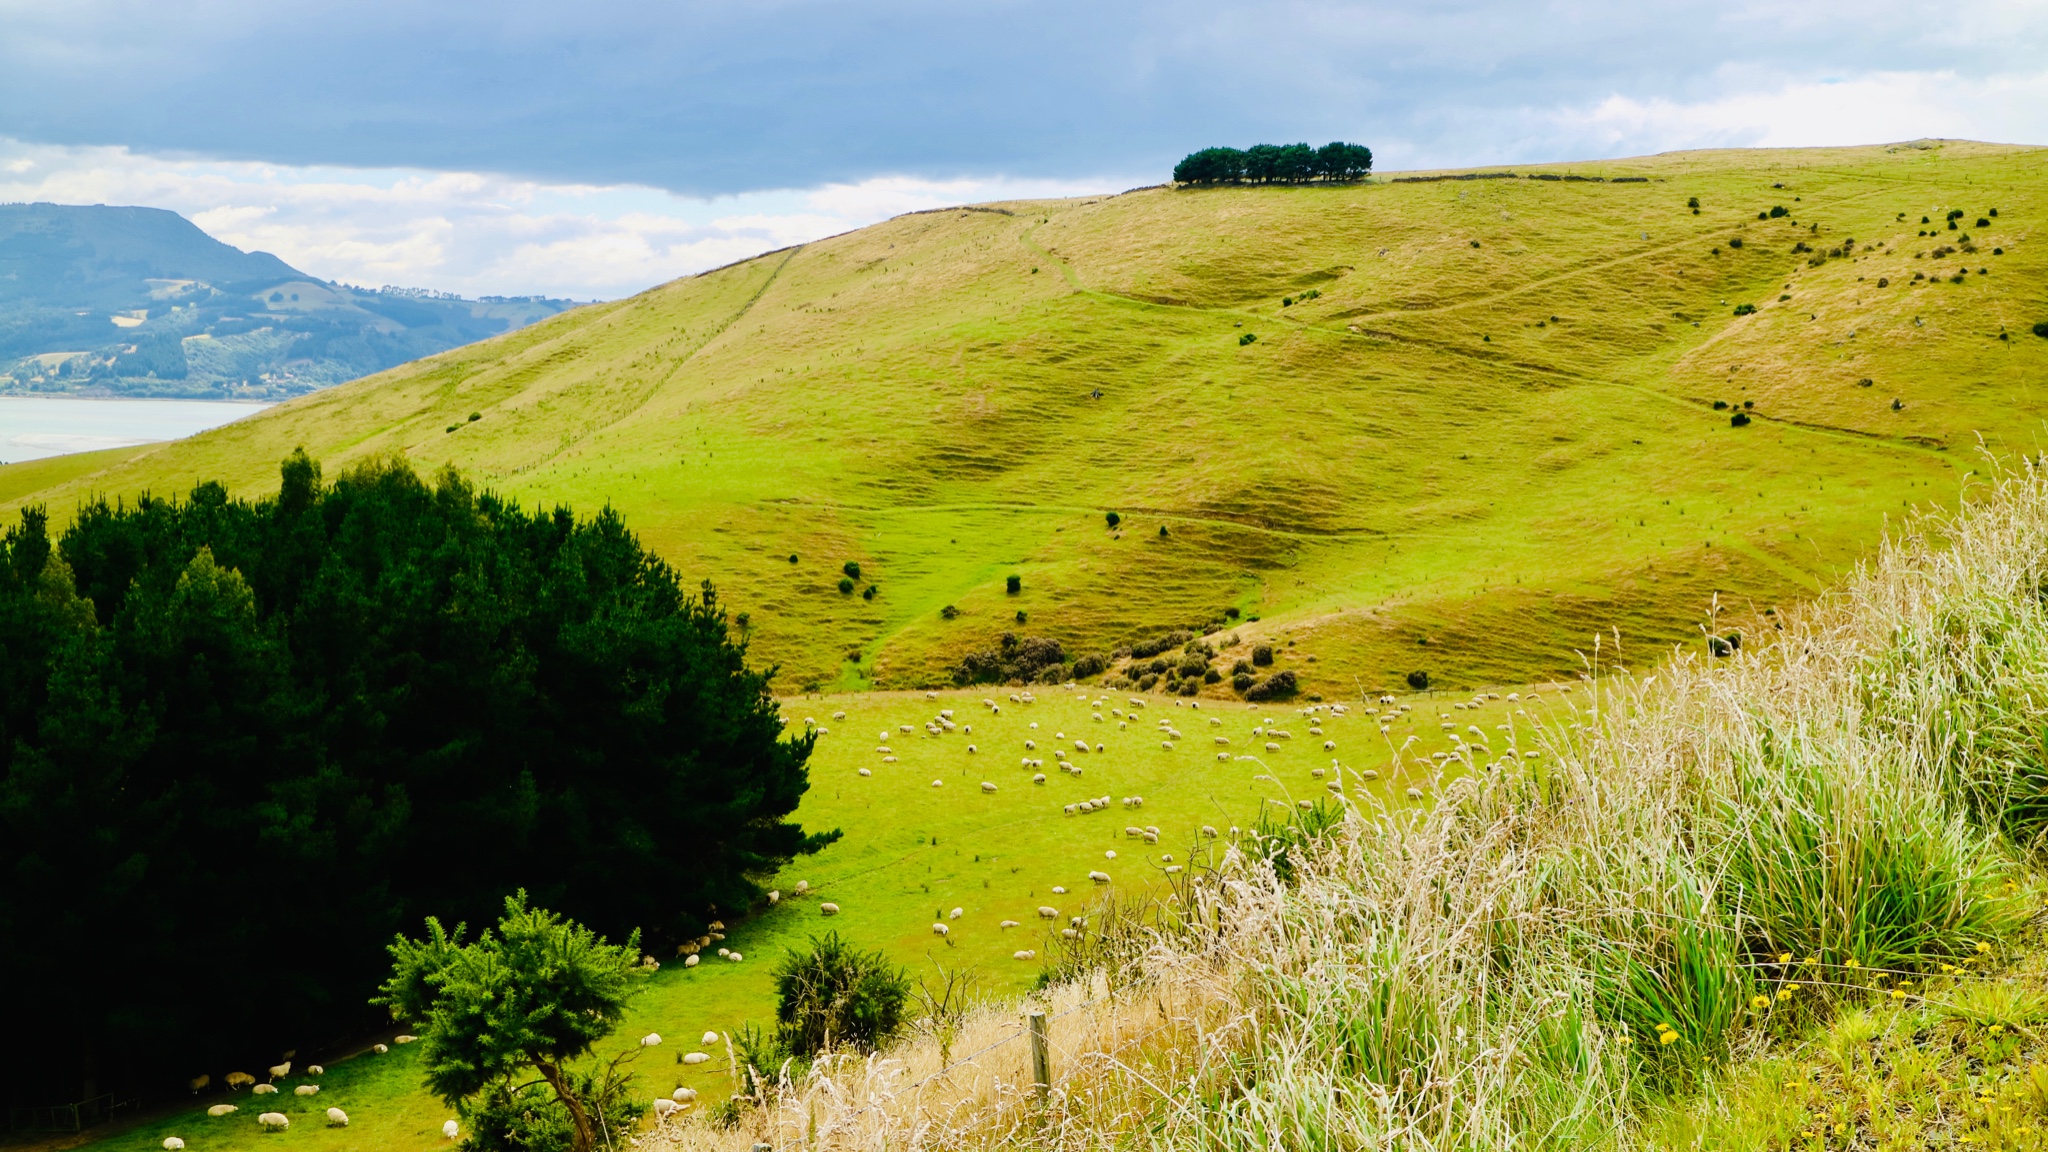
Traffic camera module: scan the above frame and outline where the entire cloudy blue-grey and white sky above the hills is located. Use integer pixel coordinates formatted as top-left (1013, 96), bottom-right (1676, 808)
top-left (0, 0), bottom-right (2048, 299)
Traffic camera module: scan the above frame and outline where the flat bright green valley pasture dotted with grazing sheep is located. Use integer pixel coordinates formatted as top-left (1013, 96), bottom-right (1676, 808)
top-left (64, 685), bottom-right (1583, 1152)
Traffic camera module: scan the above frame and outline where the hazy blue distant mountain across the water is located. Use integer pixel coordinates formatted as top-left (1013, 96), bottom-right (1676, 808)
top-left (0, 203), bottom-right (571, 400)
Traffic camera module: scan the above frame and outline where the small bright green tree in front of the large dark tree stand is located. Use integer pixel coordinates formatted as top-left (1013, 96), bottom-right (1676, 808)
top-left (371, 892), bottom-right (645, 1152)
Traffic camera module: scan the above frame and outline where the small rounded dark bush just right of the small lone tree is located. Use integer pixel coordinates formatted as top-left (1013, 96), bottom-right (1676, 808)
top-left (774, 933), bottom-right (909, 1058)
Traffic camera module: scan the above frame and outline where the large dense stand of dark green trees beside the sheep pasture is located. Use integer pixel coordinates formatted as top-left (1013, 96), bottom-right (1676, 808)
top-left (0, 453), bottom-right (838, 1103)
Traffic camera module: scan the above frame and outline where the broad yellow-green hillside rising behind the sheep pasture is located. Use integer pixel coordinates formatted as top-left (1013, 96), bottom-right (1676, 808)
top-left (0, 141), bottom-right (2048, 697)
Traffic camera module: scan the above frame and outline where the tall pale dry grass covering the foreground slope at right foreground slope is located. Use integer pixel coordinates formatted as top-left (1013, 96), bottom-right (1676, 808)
top-left (655, 461), bottom-right (2048, 1152)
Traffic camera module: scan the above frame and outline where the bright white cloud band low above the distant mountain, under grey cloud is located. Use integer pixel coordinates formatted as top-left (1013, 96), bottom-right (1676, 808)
top-left (0, 139), bottom-right (1141, 299)
